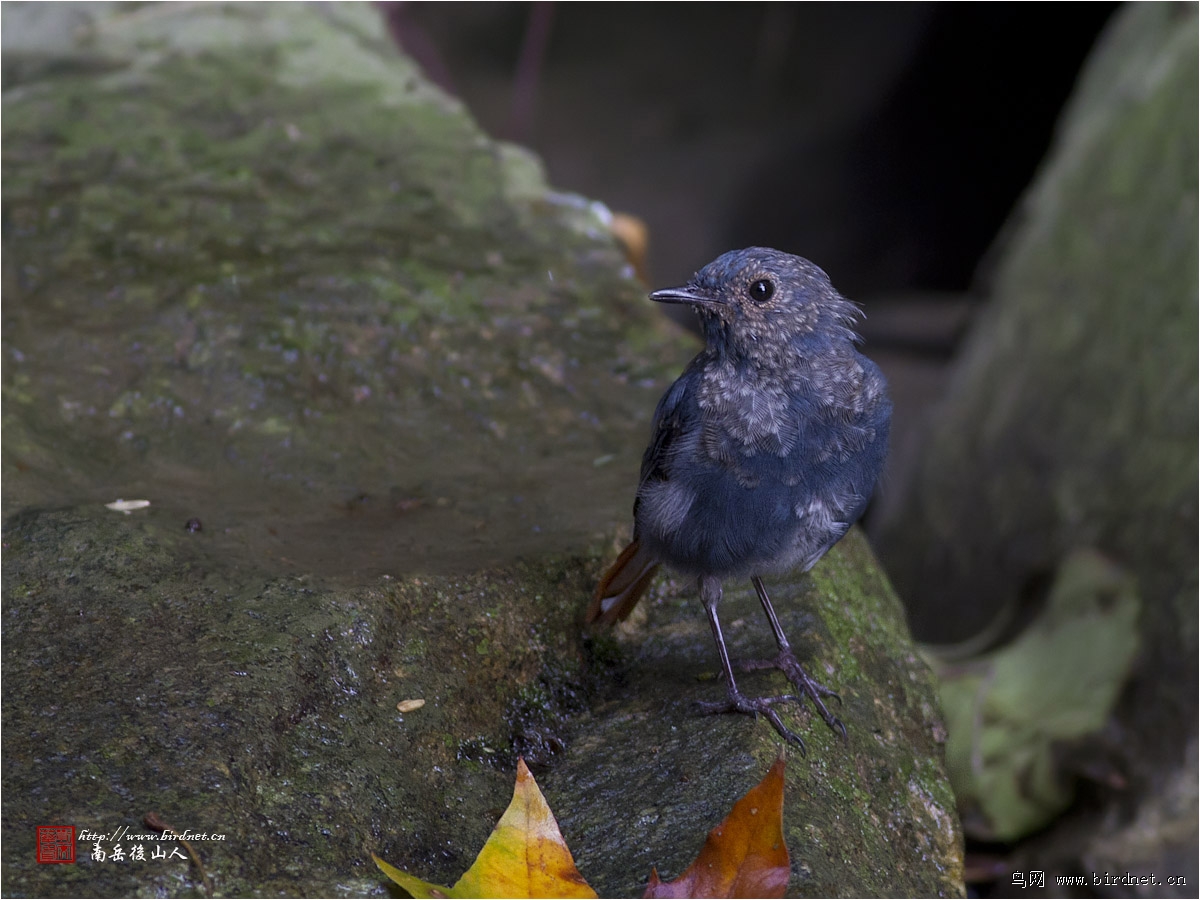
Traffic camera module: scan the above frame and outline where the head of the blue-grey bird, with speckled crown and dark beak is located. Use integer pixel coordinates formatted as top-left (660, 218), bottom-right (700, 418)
top-left (650, 247), bottom-right (859, 355)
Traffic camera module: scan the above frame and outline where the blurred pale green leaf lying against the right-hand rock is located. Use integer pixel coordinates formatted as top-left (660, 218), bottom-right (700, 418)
top-left (931, 547), bottom-right (1142, 841)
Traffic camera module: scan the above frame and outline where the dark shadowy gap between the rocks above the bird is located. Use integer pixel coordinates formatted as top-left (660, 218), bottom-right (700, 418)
top-left (385, 2), bottom-right (1115, 299)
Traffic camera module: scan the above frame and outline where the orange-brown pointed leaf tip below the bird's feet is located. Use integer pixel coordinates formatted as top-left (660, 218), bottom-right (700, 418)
top-left (643, 756), bottom-right (791, 898)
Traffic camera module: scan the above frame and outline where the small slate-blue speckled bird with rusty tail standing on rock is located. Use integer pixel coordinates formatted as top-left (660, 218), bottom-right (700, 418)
top-left (584, 247), bottom-right (892, 752)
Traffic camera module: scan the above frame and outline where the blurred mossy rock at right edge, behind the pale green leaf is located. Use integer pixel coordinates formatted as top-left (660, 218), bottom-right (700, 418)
top-left (881, 5), bottom-right (1198, 895)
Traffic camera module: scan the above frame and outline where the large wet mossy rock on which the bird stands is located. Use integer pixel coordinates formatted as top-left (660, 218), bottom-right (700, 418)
top-left (2, 4), bottom-right (961, 895)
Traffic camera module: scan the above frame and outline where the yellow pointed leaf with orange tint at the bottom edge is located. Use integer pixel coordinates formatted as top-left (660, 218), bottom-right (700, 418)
top-left (372, 760), bottom-right (596, 898)
